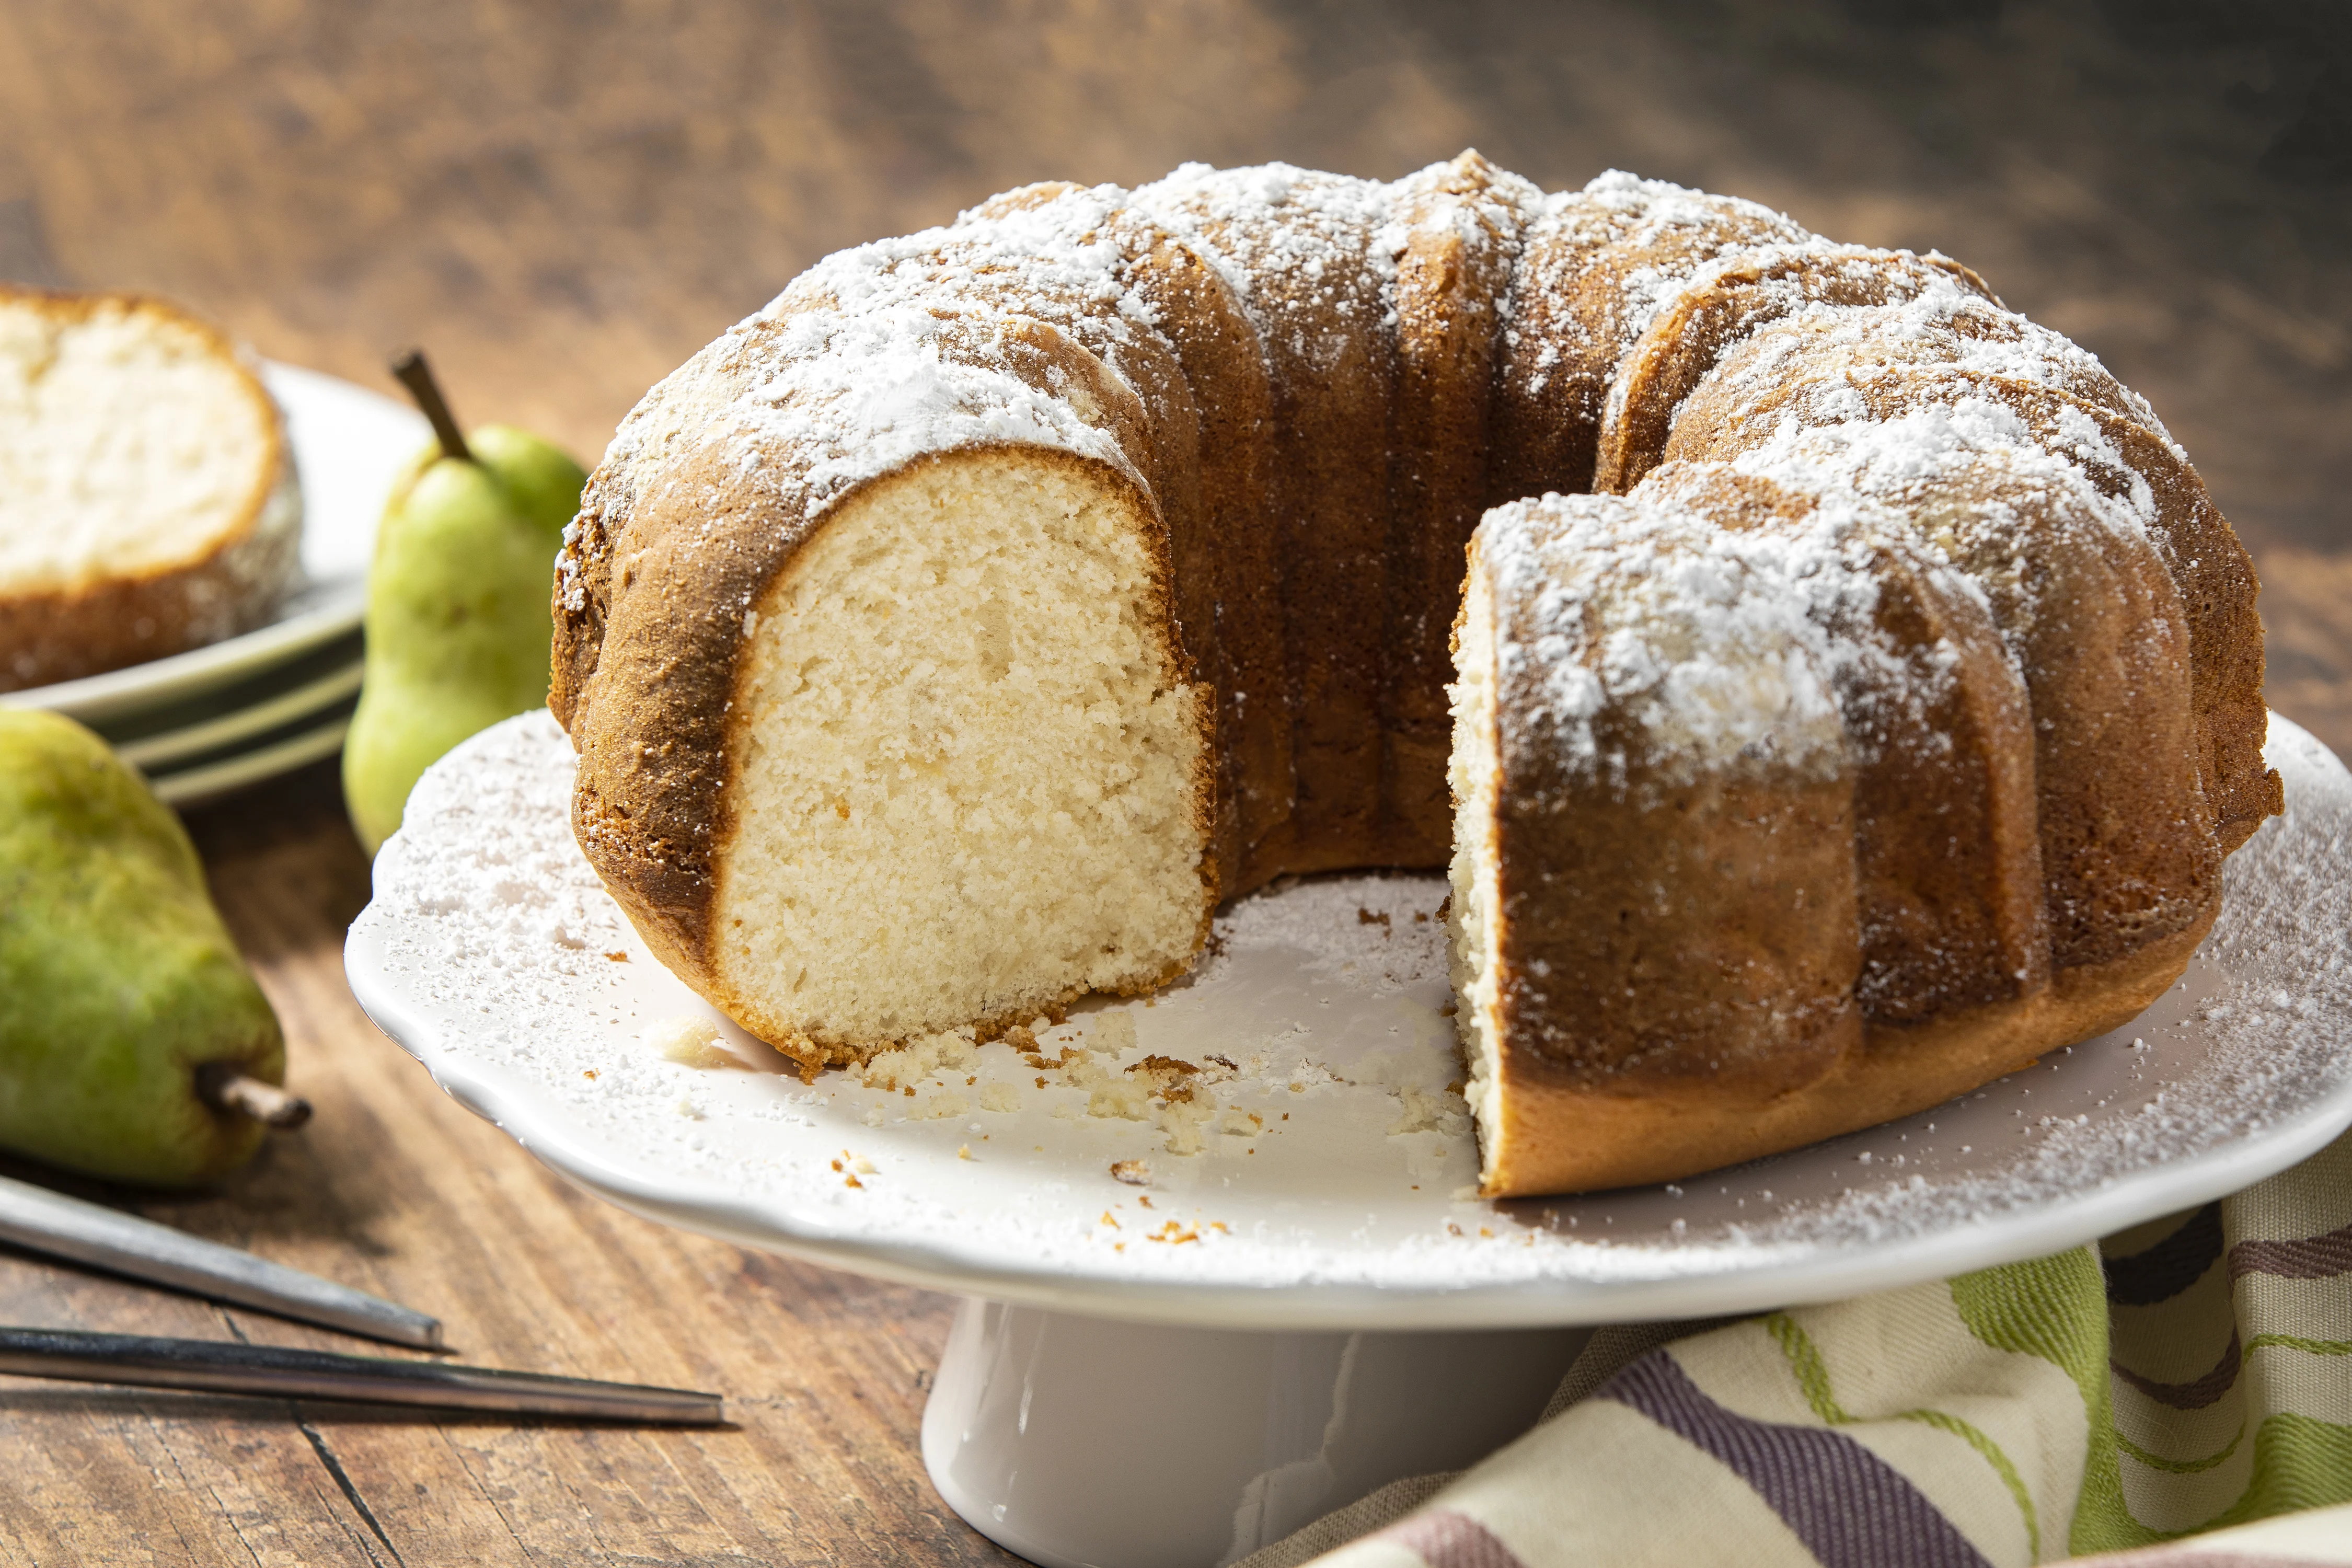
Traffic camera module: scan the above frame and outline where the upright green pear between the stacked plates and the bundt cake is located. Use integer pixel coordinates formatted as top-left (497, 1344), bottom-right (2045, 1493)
top-left (343, 425), bottom-right (588, 854)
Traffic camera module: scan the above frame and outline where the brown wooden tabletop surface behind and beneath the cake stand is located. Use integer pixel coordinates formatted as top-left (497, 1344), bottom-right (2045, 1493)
top-left (0, 0), bottom-right (2352, 1568)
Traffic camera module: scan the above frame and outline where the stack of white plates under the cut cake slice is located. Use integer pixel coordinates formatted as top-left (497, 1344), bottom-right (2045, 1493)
top-left (0, 364), bottom-right (431, 806)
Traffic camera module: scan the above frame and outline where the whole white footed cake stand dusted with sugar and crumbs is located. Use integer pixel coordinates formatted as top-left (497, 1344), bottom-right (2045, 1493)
top-left (346, 712), bottom-right (2352, 1568)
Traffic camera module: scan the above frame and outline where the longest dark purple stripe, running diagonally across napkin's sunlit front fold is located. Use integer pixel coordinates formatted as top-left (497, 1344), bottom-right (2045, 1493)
top-left (1595, 1350), bottom-right (1992, 1568)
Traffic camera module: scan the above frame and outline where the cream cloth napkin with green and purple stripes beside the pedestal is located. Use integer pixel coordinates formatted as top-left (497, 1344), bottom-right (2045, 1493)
top-left (1240, 1133), bottom-right (2352, 1568)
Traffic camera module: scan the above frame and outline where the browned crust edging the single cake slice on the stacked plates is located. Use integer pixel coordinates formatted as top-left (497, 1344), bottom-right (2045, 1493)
top-left (0, 282), bottom-right (301, 691)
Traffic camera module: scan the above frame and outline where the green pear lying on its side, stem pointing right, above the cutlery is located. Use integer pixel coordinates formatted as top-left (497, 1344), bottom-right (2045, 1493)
top-left (0, 710), bottom-right (287, 1187)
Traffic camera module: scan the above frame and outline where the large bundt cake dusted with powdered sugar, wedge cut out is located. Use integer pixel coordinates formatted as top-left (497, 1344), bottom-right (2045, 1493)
top-left (553, 153), bottom-right (2279, 1196)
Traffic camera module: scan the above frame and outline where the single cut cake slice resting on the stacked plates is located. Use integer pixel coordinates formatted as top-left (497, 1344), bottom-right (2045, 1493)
top-left (0, 284), bottom-right (301, 691)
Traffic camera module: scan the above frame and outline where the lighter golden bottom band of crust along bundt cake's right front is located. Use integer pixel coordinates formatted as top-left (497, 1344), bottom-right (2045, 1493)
top-left (1480, 912), bottom-right (2213, 1196)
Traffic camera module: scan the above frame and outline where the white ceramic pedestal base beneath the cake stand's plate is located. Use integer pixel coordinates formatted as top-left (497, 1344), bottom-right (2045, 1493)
top-left (922, 1298), bottom-right (1593, 1568)
